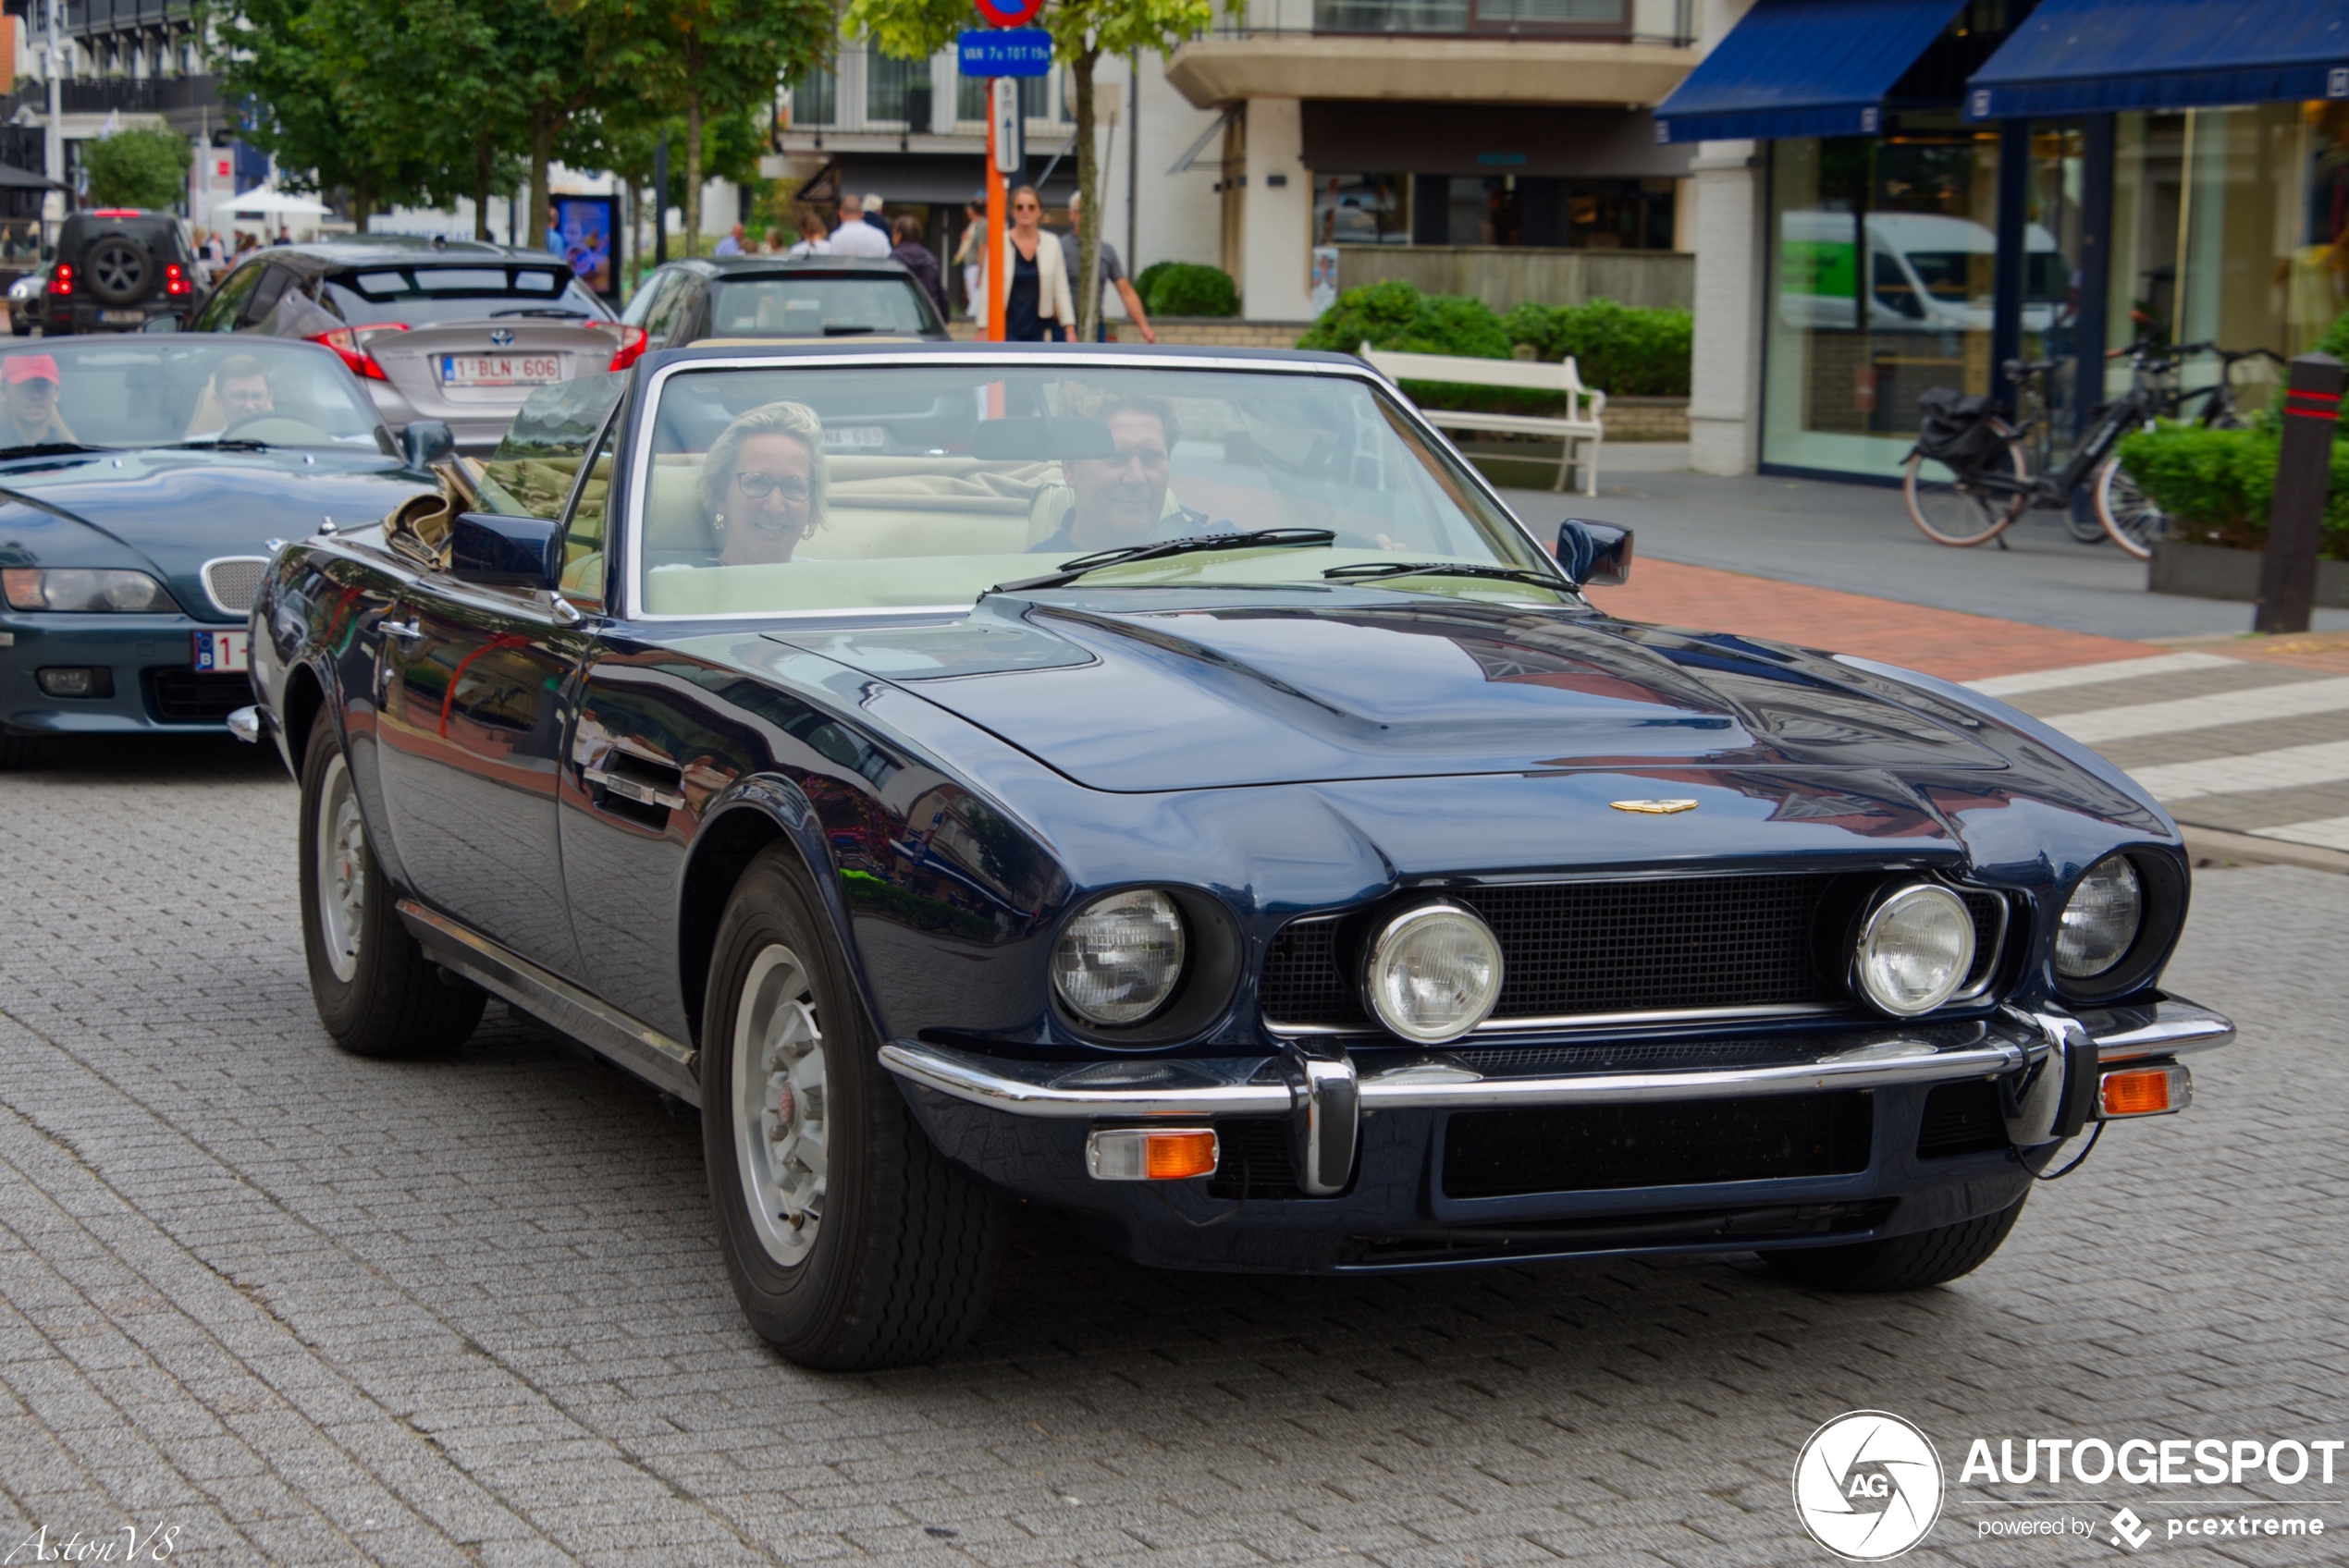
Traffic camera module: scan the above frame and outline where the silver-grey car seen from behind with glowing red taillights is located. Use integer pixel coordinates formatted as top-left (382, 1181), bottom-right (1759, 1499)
top-left (192, 235), bottom-right (644, 453)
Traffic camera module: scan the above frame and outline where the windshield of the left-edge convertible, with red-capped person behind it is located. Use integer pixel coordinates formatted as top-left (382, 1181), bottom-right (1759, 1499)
top-left (0, 334), bottom-right (392, 456)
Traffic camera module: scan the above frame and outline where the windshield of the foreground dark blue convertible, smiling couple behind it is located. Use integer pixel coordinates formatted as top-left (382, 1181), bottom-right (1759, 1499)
top-left (632, 361), bottom-right (1567, 615)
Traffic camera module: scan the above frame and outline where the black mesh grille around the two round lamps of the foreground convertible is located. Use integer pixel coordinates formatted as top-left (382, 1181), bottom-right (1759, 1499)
top-left (1261, 876), bottom-right (2006, 1028)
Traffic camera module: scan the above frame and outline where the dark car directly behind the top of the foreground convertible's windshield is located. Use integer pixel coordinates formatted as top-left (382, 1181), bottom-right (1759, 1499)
top-left (621, 256), bottom-right (947, 348)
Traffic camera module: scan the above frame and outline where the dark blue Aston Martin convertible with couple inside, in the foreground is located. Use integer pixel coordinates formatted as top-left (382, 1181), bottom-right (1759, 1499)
top-left (242, 345), bottom-right (2234, 1366)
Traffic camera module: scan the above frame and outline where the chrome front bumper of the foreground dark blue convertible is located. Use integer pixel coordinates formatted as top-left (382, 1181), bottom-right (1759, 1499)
top-left (881, 998), bottom-right (2234, 1193)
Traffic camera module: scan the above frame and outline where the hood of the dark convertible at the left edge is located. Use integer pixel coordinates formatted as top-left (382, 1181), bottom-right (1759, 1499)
top-left (0, 450), bottom-right (435, 619)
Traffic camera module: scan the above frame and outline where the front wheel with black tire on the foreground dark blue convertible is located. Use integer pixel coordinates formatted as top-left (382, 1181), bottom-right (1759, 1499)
top-left (702, 845), bottom-right (1003, 1371)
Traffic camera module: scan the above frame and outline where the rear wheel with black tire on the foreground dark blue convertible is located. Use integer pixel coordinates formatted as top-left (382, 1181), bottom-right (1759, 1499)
top-left (301, 714), bottom-right (488, 1057)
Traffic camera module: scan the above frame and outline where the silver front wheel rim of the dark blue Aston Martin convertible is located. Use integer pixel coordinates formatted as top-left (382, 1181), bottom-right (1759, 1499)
top-left (732, 944), bottom-right (831, 1268)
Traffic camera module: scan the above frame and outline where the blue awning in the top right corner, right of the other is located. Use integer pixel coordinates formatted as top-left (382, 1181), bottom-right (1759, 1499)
top-left (1963, 0), bottom-right (2349, 119)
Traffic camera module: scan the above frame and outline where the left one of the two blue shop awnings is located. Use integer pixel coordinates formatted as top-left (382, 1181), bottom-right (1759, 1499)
top-left (1656, 0), bottom-right (1963, 141)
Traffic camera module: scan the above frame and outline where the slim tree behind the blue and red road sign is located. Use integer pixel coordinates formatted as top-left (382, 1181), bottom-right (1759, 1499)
top-left (848, 0), bottom-right (1238, 340)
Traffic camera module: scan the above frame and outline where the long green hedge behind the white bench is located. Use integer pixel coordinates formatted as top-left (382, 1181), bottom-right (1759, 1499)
top-left (1297, 277), bottom-right (1696, 413)
